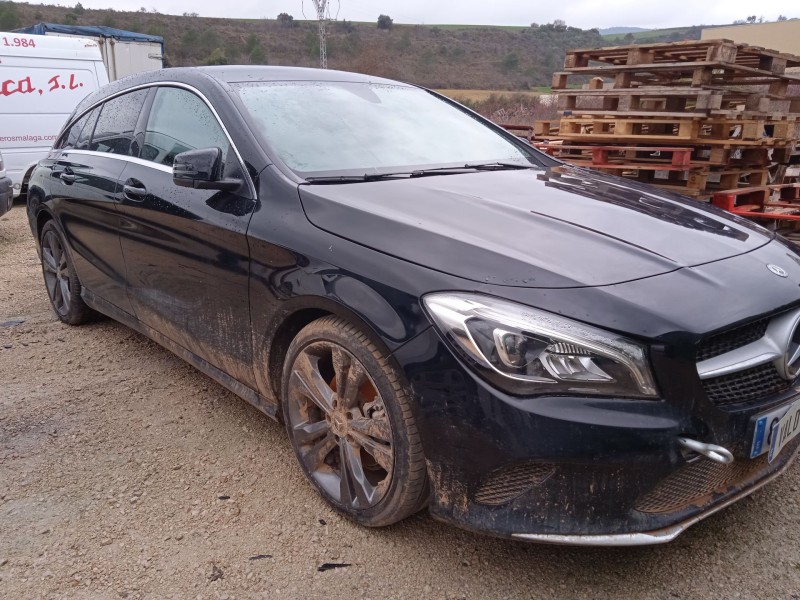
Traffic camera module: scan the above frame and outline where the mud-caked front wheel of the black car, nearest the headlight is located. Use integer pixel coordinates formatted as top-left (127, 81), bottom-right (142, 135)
top-left (282, 317), bottom-right (428, 527)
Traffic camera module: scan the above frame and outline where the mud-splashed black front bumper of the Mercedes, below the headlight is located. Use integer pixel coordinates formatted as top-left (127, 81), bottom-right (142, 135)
top-left (395, 329), bottom-right (800, 545)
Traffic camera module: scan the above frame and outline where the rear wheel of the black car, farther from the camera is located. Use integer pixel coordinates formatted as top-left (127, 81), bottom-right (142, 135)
top-left (41, 221), bottom-right (94, 325)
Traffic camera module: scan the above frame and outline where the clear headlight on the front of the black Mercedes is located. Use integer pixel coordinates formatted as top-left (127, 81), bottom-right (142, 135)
top-left (423, 292), bottom-right (658, 398)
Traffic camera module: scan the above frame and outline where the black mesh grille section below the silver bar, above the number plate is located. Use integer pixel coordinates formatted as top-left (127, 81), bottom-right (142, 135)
top-left (703, 363), bottom-right (793, 407)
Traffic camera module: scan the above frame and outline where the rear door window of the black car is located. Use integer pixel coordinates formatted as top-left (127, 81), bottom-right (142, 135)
top-left (89, 90), bottom-right (147, 156)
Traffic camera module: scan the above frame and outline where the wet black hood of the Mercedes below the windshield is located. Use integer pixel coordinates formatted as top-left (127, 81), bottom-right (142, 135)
top-left (300, 165), bottom-right (774, 288)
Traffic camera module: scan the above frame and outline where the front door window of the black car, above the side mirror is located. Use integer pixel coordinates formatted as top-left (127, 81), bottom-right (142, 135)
top-left (142, 87), bottom-right (230, 167)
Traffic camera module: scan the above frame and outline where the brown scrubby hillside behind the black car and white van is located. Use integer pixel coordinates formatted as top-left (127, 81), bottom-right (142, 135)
top-left (0, 2), bottom-right (604, 90)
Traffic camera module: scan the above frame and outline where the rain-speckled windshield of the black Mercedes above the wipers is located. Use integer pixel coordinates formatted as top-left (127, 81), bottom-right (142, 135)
top-left (237, 82), bottom-right (535, 177)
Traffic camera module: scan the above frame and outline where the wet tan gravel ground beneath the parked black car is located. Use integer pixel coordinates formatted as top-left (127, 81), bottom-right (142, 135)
top-left (0, 205), bottom-right (800, 600)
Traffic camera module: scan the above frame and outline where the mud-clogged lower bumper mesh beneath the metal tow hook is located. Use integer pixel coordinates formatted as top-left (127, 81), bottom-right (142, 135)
top-left (635, 455), bottom-right (769, 513)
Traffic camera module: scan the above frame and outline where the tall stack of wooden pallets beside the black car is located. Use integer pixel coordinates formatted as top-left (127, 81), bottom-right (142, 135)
top-left (534, 40), bottom-right (800, 214)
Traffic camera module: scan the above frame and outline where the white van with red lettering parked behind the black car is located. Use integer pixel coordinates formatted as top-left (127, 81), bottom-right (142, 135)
top-left (0, 31), bottom-right (108, 197)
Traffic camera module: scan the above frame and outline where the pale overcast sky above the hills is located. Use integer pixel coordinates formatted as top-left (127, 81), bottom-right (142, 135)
top-left (45, 0), bottom-right (800, 29)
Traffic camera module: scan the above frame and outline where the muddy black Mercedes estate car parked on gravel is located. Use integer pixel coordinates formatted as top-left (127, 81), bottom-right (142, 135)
top-left (23, 67), bottom-right (800, 545)
